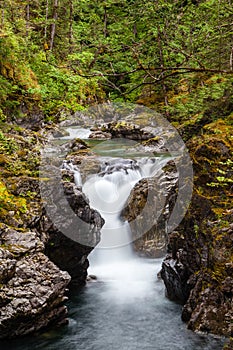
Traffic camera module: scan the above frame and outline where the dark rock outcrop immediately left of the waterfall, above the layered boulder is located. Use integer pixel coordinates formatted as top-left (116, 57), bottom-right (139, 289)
top-left (40, 179), bottom-right (104, 286)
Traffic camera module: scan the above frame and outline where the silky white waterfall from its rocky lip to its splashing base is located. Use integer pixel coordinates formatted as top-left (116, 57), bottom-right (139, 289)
top-left (78, 158), bottom-right (167, 288)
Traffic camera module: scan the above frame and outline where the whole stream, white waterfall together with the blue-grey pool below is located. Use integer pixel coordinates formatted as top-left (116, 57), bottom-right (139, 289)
top-left (0, 129), bottom-right (226, 350)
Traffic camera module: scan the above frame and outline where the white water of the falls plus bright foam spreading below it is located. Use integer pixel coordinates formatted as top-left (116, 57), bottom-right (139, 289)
top-left (82, 158), bottom-right (168, 303)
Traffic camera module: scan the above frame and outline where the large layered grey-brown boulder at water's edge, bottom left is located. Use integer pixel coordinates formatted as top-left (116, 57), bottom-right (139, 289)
top-left (0, 225), bottom-right (70, 338)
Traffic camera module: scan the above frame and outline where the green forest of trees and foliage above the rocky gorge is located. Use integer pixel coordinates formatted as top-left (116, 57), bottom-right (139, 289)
top-left (0, 0), bottom-right (233, 122)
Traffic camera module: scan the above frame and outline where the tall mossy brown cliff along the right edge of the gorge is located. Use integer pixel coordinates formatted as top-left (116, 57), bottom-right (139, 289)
top-left (161, 122), bottom-right (233, 336)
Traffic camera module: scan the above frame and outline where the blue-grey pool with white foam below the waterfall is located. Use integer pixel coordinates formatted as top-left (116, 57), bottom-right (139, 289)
top-left (0, 259), bottom-right (226, 350)
